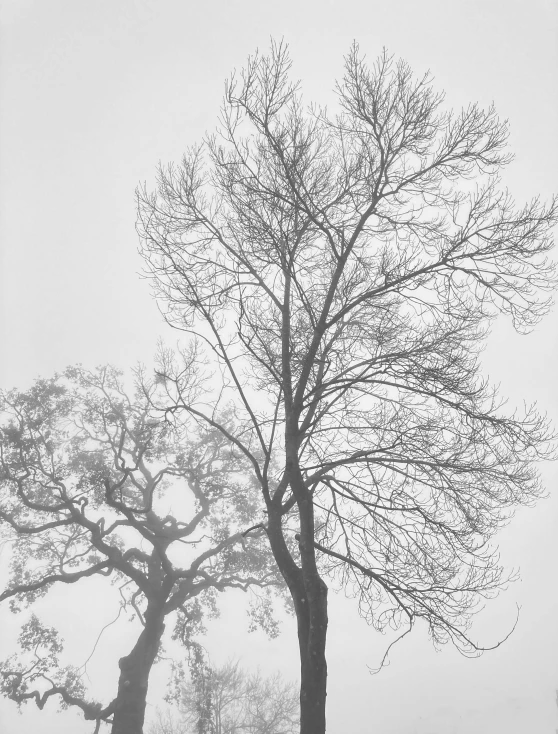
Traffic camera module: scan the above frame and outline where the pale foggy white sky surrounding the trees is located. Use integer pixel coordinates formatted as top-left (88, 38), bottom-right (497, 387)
top-left (0, 0), bottom-right (558, 734)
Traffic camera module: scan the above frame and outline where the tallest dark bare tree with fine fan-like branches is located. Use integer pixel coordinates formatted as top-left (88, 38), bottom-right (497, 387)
top-left (138, 44), bottom-right (557, 734)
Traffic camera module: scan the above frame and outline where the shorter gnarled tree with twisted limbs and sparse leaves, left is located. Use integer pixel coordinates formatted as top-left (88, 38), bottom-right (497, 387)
top-left (0, 368), bottom-right (282, 734)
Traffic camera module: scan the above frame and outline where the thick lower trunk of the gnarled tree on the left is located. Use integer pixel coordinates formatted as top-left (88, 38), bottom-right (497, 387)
top-left (111, 604), bottom-right (165, 734)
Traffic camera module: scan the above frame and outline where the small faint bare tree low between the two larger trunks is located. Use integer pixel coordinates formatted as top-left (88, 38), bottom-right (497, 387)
top-left (149, 658), bottom-right (300, 734)
